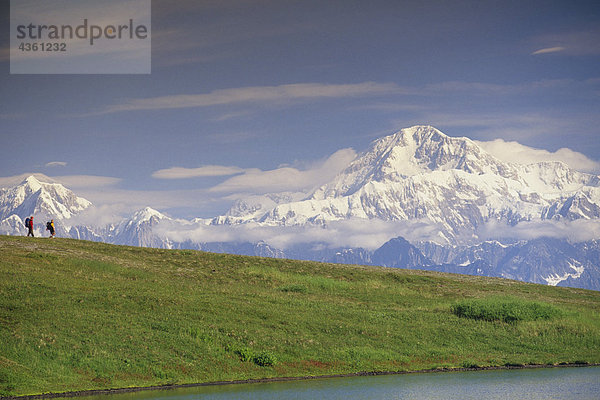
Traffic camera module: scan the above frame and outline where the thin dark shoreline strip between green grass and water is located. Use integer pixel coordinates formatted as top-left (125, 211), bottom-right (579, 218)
top-left (0, 363), bottom-right (600, 400)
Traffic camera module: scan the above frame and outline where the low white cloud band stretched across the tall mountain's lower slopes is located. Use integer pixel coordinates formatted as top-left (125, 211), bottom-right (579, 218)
top-left (153, 218), bottom-right (600, 251)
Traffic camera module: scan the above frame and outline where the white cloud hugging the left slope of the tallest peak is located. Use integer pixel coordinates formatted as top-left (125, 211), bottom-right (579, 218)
top-left (210, 149), bottom-right (356, 193)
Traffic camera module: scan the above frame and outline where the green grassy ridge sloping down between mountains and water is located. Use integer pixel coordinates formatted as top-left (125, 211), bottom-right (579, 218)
top-left (0, 236), bottom-right (600, 396)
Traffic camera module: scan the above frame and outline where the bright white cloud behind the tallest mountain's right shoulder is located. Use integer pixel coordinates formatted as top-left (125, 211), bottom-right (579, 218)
top-left (475, 139), bottom-right (600, 172)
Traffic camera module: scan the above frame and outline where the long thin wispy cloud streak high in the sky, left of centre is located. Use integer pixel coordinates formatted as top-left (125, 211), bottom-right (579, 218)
top-left (99, 82), bottom-right (400, 114)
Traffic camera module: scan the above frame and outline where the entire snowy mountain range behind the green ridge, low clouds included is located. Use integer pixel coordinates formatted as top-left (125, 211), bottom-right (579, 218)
top-left (0, 126), bottom-right (600, 290)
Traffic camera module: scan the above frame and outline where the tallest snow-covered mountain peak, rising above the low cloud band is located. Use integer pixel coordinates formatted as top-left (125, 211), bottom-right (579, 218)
top-left (213, 126), bottom-right (600, 244)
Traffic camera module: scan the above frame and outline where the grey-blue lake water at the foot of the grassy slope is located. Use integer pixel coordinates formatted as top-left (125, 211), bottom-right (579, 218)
top-left (63, 367), bottom-right (600, 400)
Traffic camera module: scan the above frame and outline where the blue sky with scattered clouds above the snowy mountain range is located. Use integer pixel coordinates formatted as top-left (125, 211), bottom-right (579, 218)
top-left (0, 0), bottom-right (600, 218)
